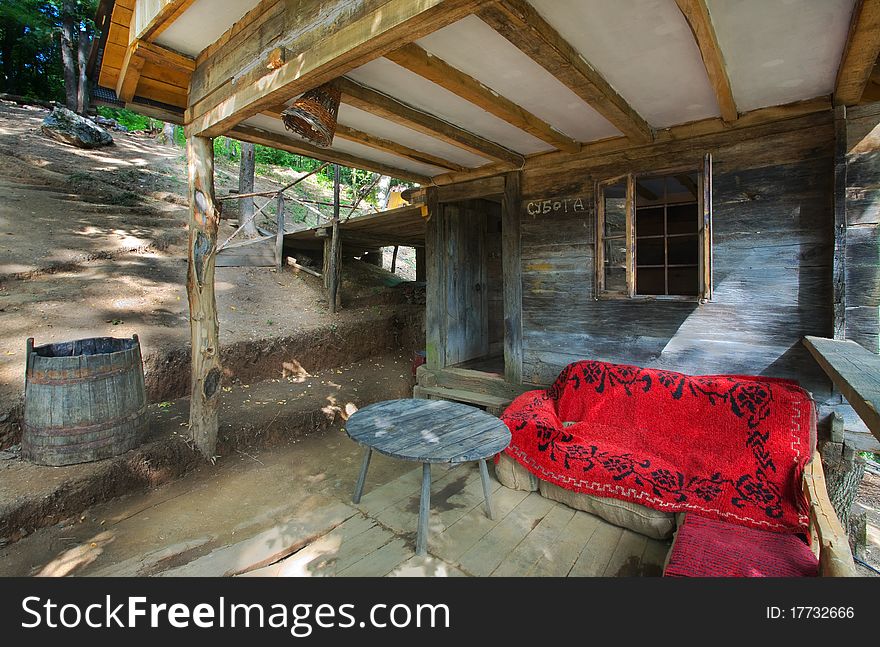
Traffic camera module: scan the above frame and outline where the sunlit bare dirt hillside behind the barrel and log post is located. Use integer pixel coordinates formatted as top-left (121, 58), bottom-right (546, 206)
top-left (0, 102), bottom-right (422, 447)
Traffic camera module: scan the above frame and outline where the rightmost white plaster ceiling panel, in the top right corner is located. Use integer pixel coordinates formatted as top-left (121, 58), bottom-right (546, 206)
top-left (707, 0), bottom-right (855, 112)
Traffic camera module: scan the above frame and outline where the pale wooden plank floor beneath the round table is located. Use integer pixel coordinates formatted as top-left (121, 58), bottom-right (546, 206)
top-left (234, 463), bottom-right (669, 577)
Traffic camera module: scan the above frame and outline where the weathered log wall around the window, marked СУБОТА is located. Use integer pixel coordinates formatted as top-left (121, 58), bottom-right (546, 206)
top-left (520, 112), bottom-right (834, 401)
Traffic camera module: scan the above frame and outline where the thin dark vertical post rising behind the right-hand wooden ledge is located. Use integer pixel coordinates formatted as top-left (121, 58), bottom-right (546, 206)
top-left (831, 106), bottom-right (846, 339)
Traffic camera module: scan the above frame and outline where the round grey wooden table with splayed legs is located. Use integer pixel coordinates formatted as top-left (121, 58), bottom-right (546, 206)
top-left (345, 399), bottom-right (510, 555)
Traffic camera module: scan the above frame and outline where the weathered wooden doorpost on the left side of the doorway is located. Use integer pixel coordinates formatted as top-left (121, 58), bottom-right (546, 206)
top-left (425, 186), bottom-right (446, 370)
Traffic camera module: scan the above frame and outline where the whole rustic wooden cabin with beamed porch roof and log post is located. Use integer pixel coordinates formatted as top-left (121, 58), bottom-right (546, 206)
top-left (91, 0), bottom-right (880, 564)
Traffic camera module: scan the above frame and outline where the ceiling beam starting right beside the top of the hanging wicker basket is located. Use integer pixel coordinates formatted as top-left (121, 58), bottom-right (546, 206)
top-left (337, 78), bottom-right (525, 167)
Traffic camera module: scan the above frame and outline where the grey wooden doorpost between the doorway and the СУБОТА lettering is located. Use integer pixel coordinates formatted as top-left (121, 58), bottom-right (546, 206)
top-left (501, 171), bottom-right (522, 384)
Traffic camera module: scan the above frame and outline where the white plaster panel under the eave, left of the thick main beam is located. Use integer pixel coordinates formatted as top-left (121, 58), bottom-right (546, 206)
top-left (156, 0), bottom-right (260, 57)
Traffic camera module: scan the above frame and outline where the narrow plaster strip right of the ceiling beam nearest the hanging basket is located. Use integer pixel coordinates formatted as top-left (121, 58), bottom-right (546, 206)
top-left (346, 58), bottom-right (554, 154)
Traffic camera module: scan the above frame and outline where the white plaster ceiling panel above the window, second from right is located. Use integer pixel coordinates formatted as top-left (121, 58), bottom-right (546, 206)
top-left (529, 0), bottom-right (720, 127)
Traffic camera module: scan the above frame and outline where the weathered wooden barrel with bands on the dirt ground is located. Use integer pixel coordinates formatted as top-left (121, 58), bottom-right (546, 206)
top-left (21, 335), bottom-right (147, 466)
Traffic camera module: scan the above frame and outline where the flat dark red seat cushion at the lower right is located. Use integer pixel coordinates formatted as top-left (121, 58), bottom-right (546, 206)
top-left (663, 514), bottom-right (819, 577)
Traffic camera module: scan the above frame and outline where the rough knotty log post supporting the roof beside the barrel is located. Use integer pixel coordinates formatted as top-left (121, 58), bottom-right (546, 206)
top-left (186, 137), bottom-right (222, 460)
